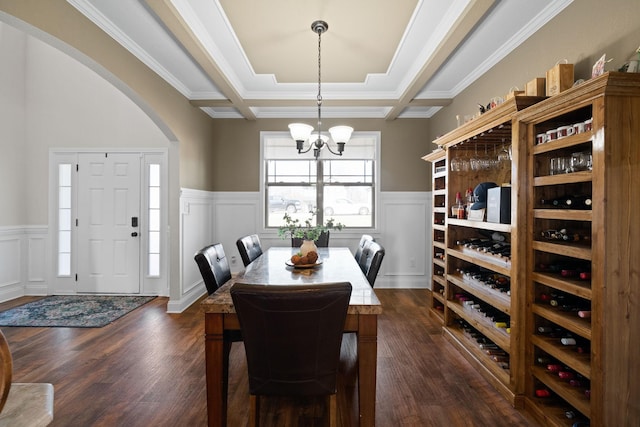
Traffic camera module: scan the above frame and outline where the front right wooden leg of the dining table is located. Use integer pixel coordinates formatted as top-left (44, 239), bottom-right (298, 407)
top-left (358, 314), bottom-right (378, 427)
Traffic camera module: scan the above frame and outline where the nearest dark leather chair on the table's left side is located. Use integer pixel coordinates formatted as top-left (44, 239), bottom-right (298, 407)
top-left (194, 243), bottom-right (242, 401)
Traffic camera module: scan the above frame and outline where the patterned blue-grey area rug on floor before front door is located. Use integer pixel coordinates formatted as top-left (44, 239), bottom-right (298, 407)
top-left (0, 295), bottom-right (155, 328)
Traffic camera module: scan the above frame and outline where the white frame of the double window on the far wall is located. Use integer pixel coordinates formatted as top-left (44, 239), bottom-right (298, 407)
top-left (259, 131), bottom-right (381, 233)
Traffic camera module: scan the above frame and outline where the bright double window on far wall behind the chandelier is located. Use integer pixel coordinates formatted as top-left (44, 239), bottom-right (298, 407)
top-left (262, 132), bottom-right (380, 228)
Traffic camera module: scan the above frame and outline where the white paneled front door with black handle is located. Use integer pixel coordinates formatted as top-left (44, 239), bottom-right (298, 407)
top-left (77, 153), bottom-right (141, 294)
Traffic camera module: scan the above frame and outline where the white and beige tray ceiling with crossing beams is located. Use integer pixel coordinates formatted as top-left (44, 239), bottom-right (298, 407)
top-left (67, 0), bottom-right (573, 120)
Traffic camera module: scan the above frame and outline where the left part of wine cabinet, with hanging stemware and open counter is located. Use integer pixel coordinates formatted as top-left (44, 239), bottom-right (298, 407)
top-left (424, 96), bottom-right (543, 406)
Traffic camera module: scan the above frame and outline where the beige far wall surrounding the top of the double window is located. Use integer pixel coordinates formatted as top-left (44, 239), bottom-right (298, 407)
top-left (206, 119), bottom-right (431, 191)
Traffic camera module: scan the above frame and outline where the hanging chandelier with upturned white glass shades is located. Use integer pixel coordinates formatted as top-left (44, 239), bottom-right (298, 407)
top-left (289, 21), bottom-right (353, 159)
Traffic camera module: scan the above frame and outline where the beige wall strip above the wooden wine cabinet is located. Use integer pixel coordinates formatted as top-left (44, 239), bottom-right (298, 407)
top-left (430, 0), bottom-right (640, 140)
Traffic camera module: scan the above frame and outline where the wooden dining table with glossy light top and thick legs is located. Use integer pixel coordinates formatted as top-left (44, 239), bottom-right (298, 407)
top-left (201, 247), bottom-right (382, 426)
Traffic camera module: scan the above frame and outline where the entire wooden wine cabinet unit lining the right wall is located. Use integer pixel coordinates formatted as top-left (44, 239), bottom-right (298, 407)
top-left (424, 72), bottom-right (640, 426)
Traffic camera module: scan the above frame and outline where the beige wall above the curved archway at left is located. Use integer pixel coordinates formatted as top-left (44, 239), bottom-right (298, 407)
top-left (0, 0), bottom-right (214, 188)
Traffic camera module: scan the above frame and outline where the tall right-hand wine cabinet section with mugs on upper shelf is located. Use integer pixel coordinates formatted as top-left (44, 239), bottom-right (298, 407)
top-left (516, 73), bottom-right (640, 426)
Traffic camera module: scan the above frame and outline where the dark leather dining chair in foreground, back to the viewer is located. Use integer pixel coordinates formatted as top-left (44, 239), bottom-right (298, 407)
top-left (230, 282), bottom-right (351, 426)
